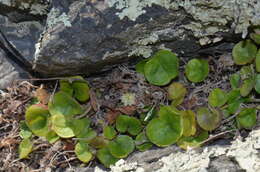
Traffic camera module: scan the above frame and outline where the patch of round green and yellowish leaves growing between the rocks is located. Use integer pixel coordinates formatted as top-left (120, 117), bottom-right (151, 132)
top-left (19, 28), bottom-right (260, 167)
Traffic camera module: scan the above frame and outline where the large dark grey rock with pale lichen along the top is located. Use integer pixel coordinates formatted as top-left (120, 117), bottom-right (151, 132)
top-left (34, 0), bottom-right (260, 76)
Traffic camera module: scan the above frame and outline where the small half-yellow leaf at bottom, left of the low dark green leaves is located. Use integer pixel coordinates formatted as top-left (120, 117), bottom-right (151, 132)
top-left (75, 142), bottom-right (93, 163)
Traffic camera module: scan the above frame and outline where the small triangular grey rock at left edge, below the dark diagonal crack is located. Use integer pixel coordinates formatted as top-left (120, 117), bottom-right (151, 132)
top-left (0, 49), bottom-right (28, 89)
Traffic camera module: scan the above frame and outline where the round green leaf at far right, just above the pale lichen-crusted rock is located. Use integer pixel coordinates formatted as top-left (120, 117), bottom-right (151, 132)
top-left (236, 108), bottom-right (256, 129)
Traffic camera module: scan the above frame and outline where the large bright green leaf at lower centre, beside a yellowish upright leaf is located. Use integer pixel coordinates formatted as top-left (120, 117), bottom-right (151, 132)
top-left (146, 106), bottom-right (183, 146)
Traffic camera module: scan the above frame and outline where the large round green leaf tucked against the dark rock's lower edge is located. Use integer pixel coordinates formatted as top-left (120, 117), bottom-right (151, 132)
top-left (144, 50), bottom-right (179, 86)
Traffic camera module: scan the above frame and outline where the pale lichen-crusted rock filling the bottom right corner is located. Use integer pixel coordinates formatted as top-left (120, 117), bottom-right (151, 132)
top-left (91, 129), bottom-right (260, 172)
